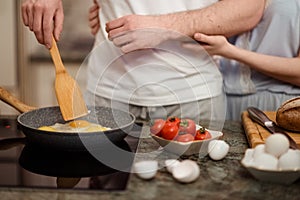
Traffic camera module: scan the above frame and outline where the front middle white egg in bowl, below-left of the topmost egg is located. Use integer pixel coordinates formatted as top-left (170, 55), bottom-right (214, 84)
top-left (254, 153), bottom-right (278, 170)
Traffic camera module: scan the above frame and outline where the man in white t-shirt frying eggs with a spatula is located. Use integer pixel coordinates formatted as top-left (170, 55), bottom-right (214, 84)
top-left (22, 0), bottom-right (264, 129)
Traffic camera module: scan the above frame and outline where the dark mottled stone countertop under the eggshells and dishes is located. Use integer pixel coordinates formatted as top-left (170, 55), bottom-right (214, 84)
top-left (0, 121), bottom-right (300, 200)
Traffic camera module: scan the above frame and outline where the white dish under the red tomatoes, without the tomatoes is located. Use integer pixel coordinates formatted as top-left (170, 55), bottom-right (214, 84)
top-left (151, 125), bottom-right (223, 156)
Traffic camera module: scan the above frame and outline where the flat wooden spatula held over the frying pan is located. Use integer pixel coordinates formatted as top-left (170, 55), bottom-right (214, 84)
top-left (50, 37), bottom-right (88, 121)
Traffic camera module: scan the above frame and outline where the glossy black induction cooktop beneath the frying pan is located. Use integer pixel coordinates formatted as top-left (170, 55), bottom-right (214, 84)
top-left (0, 116), bottom-right (142, 190)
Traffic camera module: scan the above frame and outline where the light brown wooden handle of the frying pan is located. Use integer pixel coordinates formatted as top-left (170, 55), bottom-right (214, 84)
top-left (0, 87), bottom-right (36, 113)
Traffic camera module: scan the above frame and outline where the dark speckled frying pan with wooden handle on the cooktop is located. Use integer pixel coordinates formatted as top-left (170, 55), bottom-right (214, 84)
top-left (0, 87), bottom-right (135, 151)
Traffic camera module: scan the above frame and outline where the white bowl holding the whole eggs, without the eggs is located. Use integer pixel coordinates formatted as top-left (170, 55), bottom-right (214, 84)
top-left (241, 149), bottom-right (300, 185)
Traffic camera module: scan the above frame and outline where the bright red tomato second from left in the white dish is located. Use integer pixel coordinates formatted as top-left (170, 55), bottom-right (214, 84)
top-left (161, 117), bottom-right (180, 140)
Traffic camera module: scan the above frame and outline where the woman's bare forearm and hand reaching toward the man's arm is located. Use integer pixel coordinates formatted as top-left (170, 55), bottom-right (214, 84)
top-left (194, 33), bottom-right (300, 86)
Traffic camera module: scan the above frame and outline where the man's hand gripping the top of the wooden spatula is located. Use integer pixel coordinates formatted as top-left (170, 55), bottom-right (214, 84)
top-left (22, 0), bottom-right (64, 48)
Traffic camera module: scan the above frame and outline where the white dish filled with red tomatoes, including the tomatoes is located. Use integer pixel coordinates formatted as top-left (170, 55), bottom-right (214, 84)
top-left (150, 117), bottom-right (223, 155)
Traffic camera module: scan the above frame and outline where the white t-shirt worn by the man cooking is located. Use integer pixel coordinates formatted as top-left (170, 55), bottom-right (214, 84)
top-left (87, 0), bottom-right (222, 106)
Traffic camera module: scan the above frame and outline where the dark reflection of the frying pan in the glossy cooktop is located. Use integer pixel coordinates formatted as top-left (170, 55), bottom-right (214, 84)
top-left (19, 140), bottom-right (133, 178)
